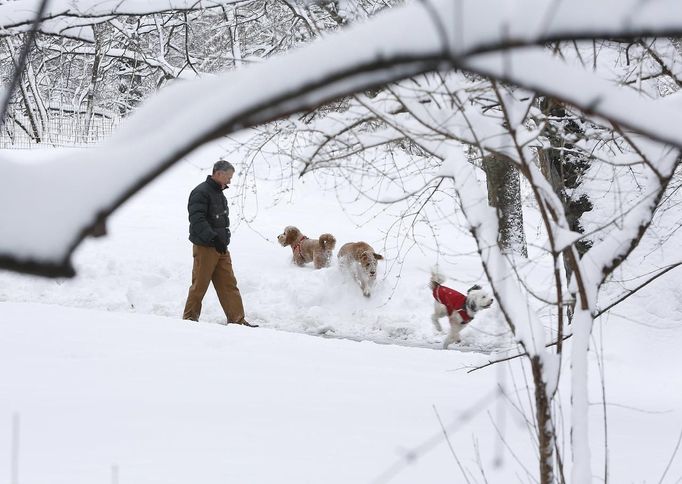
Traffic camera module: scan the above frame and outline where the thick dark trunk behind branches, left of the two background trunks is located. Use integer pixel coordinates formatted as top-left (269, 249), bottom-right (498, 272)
top-left (483, 156), bottom-right (528, 257)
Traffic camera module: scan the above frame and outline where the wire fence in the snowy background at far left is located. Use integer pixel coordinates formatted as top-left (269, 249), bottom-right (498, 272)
top-left (0, 108), bottom-right (120, 149)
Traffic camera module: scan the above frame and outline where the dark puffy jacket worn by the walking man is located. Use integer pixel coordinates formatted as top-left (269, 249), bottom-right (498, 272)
top-left (187, 175), bottom-right (230, 247)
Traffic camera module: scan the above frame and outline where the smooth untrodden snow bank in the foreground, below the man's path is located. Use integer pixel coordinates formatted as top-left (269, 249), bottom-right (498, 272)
top-left (0, 302), bottom-right (682, 484)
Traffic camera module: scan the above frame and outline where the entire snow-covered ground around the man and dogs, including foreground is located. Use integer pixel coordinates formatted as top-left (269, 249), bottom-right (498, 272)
top-left (0, 144), bottom-right (682, 484)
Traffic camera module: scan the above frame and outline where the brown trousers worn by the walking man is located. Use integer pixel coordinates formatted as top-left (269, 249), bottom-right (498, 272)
top-left (182, 244), bottom-right (244, 323)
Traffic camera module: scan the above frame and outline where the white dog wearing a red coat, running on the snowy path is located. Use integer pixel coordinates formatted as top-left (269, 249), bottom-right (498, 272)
top-left (430, 272), bottom-right (493, 349)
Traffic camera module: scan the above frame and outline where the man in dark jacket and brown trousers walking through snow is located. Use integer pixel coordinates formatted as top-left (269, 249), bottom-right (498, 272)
top-left (182, 160), bottom-right (258, 328)
